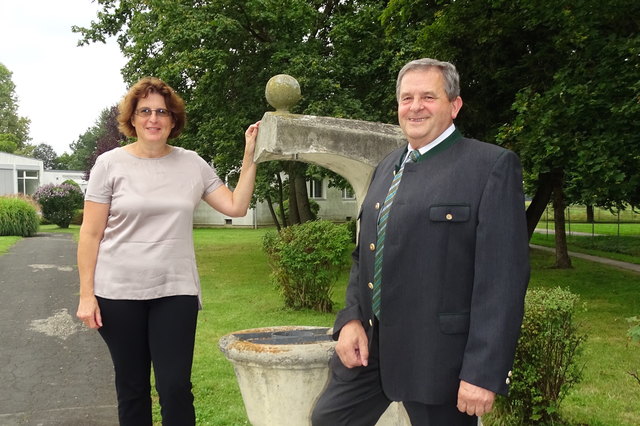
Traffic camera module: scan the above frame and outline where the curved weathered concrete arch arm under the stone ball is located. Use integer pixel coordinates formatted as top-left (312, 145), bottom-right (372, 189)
top-left (254, 112), bottom-right (407, 206)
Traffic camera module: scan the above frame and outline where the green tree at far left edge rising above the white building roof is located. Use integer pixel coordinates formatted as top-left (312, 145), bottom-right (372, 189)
top-left (0, 63), bottom-right (30, 152)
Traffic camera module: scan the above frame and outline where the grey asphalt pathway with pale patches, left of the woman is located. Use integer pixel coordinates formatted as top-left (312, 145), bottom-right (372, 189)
top-left (0, 233), bottom-right (118, 426)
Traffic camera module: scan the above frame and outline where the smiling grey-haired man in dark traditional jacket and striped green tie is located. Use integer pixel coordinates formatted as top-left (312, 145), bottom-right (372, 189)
top-left (312, 59), bottom-right (529, 426)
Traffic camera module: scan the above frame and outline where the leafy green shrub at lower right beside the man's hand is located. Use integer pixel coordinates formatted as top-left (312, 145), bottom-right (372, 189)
top-left (483, 288), bottom-right (586, 426)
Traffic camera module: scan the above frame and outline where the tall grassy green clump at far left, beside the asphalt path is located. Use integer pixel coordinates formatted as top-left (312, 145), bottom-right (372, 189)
top-left (0, 197), bottom-right (40, 237)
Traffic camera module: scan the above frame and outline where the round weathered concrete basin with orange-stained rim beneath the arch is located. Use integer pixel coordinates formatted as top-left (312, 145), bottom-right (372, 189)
top-left (219, 326), bottom-right (411, 426)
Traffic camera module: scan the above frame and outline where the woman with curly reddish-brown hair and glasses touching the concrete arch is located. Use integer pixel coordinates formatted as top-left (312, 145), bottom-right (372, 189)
top-left (77, 78), bottom-right (260, 426)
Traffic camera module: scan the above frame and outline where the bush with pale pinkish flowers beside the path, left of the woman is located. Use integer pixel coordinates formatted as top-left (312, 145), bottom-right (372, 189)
top-left (33, 183), bottom-right (84, 228)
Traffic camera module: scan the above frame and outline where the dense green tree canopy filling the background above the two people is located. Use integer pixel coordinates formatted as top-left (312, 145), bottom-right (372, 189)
top-left (75, 0), bottom-right (640, 246)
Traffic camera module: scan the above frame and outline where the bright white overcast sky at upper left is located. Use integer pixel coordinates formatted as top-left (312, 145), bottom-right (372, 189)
top-left (0, 0), bottom-right (126, 155)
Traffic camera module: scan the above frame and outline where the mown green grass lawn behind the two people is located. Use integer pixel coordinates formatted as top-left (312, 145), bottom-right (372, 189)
top-left (0, 227), bottom-right (640, 426)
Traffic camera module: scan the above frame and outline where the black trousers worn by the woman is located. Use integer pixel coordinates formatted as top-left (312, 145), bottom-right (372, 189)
top-left (98, 296), bottom-right (198, 426)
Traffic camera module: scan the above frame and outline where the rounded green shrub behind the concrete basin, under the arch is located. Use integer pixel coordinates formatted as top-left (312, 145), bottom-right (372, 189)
top-left (263, 220), bottom-right (350, 312)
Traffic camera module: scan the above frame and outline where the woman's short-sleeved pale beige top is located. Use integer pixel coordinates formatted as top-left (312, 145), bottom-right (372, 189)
top-left (85, 147), bottom-right (223, 306)
